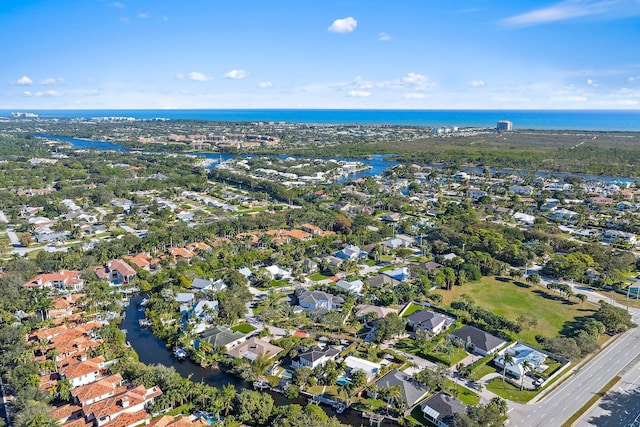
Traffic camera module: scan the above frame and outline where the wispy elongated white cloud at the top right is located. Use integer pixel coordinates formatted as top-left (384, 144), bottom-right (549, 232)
top-left (502, 0), bottom-right (640, 26)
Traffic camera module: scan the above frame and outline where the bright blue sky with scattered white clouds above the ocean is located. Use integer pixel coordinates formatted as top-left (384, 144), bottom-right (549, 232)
top-left (0, 0), bottom-right (640, 109)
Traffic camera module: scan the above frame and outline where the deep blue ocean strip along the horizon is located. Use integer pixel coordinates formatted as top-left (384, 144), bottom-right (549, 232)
top-left (0, 109), bottom-right (640, 131)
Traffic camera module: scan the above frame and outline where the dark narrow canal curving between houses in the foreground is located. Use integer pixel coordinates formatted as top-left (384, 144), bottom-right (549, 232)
top-left (120, 297), bottom-right (396, 427)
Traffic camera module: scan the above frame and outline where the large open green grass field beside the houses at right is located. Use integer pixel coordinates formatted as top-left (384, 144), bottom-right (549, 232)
top-left (438, 277), bottom-right (596, 342)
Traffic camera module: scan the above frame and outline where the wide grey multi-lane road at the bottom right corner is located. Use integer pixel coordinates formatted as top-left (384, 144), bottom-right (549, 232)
top-left (509, 310), bottom-right (640, 427)
